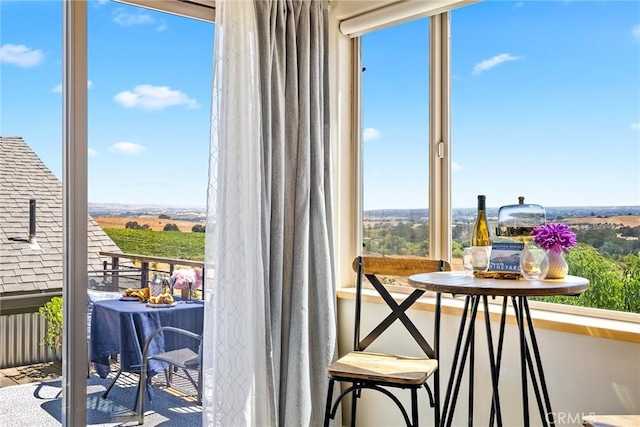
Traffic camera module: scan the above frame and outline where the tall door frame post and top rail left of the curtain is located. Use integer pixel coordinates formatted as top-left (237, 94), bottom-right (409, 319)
top-left (61, 0), bottom-right (215, 426)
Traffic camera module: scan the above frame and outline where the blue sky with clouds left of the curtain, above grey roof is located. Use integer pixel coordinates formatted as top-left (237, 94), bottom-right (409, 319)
top-left (0, 0), bottom-right (214, 206)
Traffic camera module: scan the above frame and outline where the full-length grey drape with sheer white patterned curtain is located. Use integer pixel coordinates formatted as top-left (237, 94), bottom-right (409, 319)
top-left (203, 0), bottom-right (336, 426)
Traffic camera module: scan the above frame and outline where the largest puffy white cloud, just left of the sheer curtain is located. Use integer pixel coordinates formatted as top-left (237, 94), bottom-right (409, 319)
top-left (113, 85), bottom-right (198, 110)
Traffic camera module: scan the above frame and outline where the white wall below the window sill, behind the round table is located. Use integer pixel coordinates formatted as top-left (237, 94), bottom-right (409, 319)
top-left (338, 299), bottom-right (640, 427)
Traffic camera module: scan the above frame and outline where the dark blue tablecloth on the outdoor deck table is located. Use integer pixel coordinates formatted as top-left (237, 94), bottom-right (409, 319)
top-left (90, 300), bottom-right (204, 378)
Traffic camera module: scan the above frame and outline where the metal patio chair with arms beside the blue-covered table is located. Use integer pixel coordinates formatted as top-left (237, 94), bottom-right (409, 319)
top-left (134, 326), bottom-right (202, 425)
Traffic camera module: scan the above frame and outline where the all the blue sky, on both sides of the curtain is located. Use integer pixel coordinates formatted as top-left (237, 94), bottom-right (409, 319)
top-left (0, 0), bottom-right (640, 209)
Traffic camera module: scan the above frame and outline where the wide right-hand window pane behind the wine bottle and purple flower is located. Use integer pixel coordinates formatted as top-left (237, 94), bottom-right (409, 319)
top-left (451, 2), bottom-right (640, 313)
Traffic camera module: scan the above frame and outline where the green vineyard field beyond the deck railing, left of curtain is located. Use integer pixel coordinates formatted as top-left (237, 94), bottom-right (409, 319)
top-left (103, 228), bottom-right (204, 261)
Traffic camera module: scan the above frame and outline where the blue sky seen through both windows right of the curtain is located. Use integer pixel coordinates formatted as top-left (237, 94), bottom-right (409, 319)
top-left (363, 1), bottom-right (640, 209)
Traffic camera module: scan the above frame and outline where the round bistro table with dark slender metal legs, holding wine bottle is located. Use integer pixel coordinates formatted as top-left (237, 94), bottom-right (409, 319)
top-left (409, 271), bottom-right (589, 426)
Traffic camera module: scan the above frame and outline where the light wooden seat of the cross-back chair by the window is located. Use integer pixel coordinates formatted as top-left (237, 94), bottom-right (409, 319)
top-left (327, 351), bottom-right (438, 387)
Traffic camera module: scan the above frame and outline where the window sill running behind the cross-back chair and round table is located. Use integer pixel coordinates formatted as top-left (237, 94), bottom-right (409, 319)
top-left (337, 288), bottom-right (640, 343)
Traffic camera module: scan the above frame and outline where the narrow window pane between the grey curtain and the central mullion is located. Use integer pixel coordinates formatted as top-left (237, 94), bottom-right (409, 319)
top-left (362, 18), bottom-right (429, 268)
